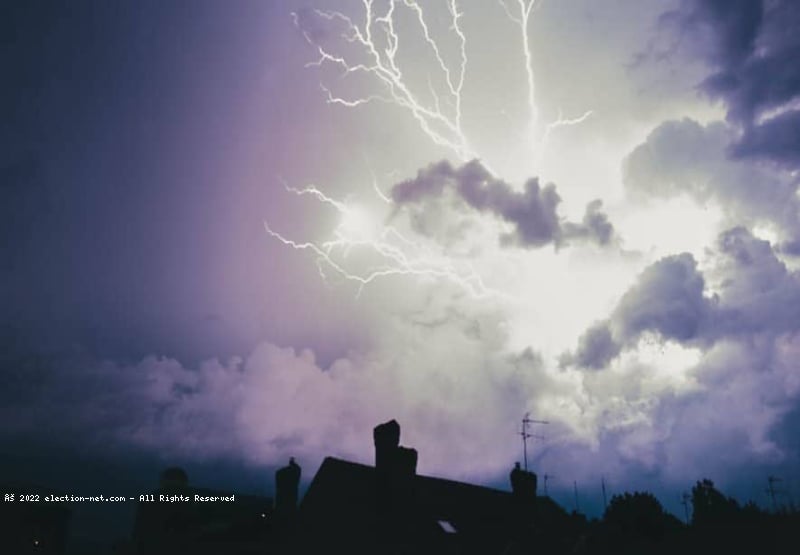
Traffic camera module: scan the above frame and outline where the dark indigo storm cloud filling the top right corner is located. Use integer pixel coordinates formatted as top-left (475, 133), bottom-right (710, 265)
top-left (678, 0), bottom-right (800, 167)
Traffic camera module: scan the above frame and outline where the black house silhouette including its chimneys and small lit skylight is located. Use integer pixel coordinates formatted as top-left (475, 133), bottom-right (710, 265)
top-left (282, 420), bottom-right (574, 555)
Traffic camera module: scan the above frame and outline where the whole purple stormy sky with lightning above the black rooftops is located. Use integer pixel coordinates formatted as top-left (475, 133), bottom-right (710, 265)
top-left (0, 0), bottom-right (800, 548)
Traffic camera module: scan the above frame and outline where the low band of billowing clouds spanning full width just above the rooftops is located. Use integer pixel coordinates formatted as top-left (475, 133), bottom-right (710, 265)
top-left (6, 223), bottom-right (800, 490)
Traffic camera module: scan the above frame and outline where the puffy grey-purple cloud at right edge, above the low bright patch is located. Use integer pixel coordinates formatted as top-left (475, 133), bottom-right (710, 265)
top-left (565, 227), bottom-right (800, 369)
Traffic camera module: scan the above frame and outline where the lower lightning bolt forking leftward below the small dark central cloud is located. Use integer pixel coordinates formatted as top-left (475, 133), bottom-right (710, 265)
top-left (264, 179), bottom-right (509, 299)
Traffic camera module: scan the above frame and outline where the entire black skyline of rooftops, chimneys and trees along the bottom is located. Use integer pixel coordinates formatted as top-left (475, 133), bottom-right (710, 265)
top-left (0, 420), bottom-right (800, 555)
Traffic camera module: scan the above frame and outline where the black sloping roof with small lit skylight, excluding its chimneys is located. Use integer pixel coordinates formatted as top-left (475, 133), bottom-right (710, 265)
top-left (290, 457), bottom-right (566, 553)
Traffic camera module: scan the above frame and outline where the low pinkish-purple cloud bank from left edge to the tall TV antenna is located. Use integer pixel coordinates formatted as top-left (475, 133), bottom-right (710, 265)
top-left (0, 298), bottom-right (567, 477)
